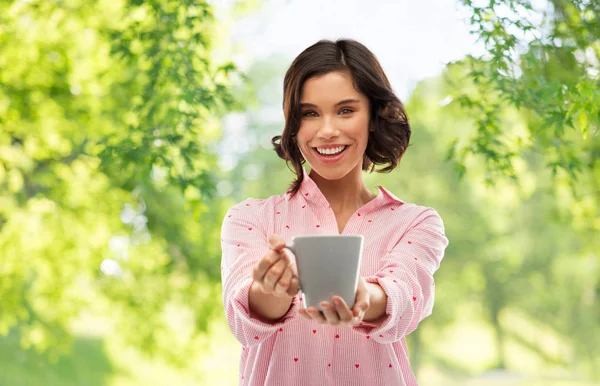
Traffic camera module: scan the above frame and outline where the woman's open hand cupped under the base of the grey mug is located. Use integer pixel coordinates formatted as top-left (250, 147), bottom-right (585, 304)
top-left (298, 277), bottom-right (370, 327)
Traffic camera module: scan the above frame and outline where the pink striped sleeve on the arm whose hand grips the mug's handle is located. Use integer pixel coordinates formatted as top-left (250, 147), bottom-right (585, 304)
top-left (221, 199), bottom-right (298, 347)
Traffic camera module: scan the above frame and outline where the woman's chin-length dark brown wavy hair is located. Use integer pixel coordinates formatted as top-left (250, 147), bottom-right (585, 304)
top-left (271, 39), bottom-right (410, 195)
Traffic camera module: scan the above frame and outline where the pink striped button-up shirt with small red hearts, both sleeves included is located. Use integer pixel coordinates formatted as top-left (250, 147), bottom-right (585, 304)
top-left (221, 170), bottom-right (448, 386)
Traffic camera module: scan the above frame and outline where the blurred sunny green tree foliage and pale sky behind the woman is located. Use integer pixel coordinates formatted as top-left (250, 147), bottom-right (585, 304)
top-left (0, 0), bottom-right (600, 386)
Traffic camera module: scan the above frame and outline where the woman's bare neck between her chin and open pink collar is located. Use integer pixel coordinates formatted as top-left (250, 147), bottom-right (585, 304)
top-left (309, 164), bottom-right (376, 214)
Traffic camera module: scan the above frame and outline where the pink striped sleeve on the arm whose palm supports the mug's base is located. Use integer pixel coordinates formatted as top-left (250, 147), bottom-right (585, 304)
top-left (353, 208), bottom-right (448, 343)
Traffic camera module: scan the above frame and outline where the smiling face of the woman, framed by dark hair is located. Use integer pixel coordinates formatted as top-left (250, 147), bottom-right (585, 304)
top-left (297, 72), bottom-right (369, 180)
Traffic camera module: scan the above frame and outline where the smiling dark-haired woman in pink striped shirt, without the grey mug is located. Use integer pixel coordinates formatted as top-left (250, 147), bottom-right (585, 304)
top-left (222, 40), bottom-right (448, 386)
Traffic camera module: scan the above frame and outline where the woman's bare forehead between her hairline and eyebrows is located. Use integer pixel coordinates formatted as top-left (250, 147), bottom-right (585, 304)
top-left (300, 72), bottom-right (367, 105)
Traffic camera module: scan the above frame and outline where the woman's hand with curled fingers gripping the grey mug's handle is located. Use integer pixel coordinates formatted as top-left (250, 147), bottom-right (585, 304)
top-left (252, 234), bottom-right (300, 297)
